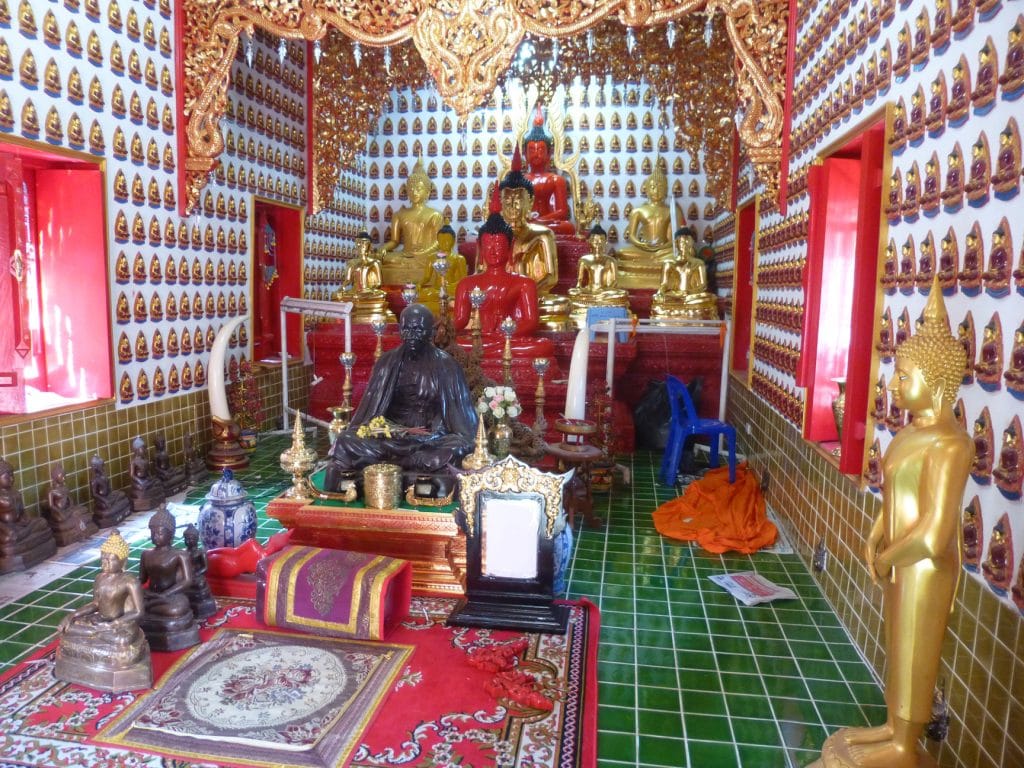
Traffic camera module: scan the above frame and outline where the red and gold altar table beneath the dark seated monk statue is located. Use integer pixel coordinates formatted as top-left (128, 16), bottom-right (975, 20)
top-left (266, 489), bottom-right (466, 596)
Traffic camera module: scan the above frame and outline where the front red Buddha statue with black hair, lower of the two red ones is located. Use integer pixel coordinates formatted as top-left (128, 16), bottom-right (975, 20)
top-left (454, 184), bottom-right (554, 357)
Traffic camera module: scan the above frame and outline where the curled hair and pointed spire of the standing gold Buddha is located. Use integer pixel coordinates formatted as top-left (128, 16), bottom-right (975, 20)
top-left (896, 273), bottom-right (967, 402)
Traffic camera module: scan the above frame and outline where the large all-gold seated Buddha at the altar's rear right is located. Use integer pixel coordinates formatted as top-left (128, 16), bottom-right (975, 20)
top-left (618, 160), bottom-right (672, 288)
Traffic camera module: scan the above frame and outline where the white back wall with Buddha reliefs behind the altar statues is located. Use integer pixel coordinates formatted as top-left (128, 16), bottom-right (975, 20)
top-left (366, 82), bottom-right (716, 252)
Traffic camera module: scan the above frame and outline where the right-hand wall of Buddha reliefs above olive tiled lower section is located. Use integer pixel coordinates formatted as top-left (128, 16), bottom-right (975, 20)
top-left (718, 0), bottom-right (1024, 766)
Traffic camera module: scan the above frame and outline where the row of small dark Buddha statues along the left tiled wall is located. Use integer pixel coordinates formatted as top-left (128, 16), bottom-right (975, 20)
top-left (0, 434), bottom-right (209, 573)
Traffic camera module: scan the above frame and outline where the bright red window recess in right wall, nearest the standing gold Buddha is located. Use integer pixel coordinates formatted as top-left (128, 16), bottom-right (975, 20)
top-left (797, 120), bottom-right (885, 474)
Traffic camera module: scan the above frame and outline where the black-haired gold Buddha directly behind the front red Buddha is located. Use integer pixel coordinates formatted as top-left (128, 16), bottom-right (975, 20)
top-left (492, 147), bottom-right (569, 331)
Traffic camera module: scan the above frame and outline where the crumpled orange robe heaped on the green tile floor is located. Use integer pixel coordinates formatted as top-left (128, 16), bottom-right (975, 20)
top-left (654, 462), bottom-right (778, 554)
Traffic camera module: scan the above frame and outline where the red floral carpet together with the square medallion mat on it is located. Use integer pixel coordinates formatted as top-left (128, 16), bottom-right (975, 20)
top-left (0, 597), bottom-right (599, 768)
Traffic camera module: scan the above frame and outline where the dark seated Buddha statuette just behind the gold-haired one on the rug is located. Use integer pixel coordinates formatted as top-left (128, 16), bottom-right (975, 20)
top-left (138, 505), bottom-right (199, 650)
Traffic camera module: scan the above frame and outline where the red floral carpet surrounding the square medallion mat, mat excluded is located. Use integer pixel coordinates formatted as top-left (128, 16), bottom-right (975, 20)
top-left (0, 598), bottom-right (599, 768)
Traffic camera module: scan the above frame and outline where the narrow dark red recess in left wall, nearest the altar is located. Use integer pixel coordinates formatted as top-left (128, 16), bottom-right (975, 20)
top-left (252, 200), bottom-right (304, 362)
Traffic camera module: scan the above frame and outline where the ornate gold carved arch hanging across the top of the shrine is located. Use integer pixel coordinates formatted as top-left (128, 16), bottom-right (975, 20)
top-left (180, 0), bottom-right (788, 213)
